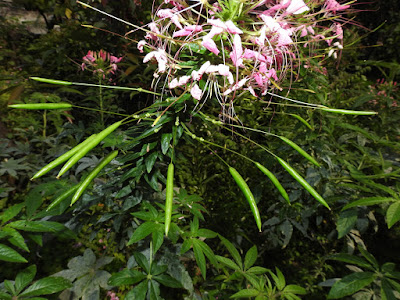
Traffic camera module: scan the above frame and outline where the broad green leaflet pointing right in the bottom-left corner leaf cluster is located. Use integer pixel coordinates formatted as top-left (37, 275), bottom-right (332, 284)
top-left (20, 277), bottom-right (72, 297)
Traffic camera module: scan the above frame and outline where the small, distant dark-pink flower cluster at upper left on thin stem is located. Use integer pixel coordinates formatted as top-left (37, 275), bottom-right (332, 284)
top-left (81, 50), bottom-right (122, 79)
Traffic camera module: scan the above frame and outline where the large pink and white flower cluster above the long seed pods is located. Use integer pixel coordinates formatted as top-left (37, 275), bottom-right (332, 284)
top-left (138, 0), bottom-right (349, 116)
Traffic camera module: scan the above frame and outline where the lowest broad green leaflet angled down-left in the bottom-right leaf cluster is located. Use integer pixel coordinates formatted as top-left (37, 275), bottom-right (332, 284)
top-left (328, 272), bottom-right (375, 299)
